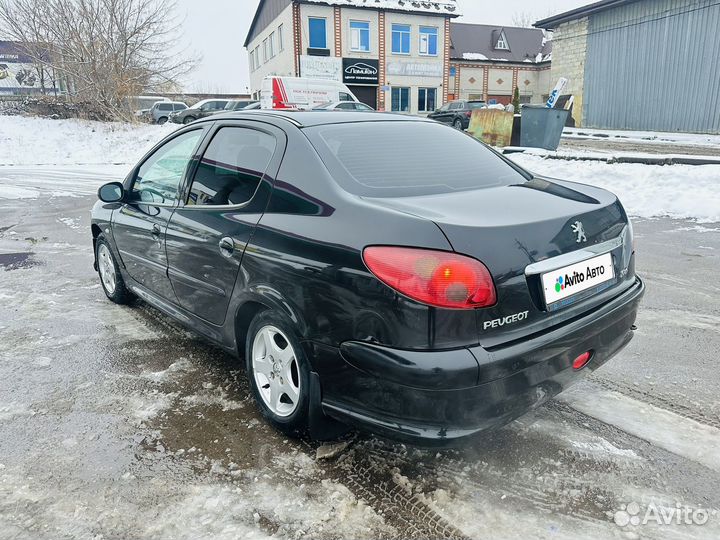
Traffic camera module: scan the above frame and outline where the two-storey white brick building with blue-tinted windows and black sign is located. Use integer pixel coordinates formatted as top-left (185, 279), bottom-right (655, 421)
top-left (245, 0), bottom-right (460, 114)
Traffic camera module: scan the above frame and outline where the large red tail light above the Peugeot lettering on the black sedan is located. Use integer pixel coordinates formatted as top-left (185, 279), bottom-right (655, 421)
top-left (363, 246), bottom-right (497, 309)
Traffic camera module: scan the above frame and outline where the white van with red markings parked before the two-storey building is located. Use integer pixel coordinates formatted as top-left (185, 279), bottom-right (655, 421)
top-left (260, 76), bottom-right (360, 110)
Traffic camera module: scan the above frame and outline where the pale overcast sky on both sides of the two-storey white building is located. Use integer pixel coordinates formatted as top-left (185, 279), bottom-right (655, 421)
top-left (177, 0), bottom-right (594, 93)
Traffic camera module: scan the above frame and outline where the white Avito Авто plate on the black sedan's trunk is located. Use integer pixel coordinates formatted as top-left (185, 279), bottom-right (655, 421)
top-left (542, 253), bottom-right (615, 305)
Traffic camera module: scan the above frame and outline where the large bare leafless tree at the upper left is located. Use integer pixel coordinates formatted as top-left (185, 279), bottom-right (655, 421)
top-left (0, 0), bottom-right (197, 117)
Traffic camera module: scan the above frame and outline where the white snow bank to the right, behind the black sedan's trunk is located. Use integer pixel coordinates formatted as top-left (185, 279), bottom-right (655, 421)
top-left (508, 154), bottom-right (720, 223)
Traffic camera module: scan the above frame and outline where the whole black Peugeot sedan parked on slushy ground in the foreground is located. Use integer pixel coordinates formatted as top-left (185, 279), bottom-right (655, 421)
top-left (92, 111), bottom-right (644, 443)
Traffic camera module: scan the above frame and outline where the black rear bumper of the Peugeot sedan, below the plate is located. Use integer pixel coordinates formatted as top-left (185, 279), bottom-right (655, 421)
top-left (321, 278), bottom-right (645, 445)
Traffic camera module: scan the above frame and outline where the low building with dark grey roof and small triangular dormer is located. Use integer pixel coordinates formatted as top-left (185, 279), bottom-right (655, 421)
top-left (449, 22), bottom-right (553, 105)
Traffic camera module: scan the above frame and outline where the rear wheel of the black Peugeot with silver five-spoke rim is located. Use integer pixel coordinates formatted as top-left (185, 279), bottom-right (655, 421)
top-left (245, 310), bottom-right (310, 436)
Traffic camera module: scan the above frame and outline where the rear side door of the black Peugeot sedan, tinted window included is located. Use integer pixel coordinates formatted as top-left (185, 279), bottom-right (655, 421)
top-left (166, 121), bottom-right (286, 325)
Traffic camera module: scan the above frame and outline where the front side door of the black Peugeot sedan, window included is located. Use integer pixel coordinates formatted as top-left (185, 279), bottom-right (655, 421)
top-left (112, 127), bottom-right (205, 302)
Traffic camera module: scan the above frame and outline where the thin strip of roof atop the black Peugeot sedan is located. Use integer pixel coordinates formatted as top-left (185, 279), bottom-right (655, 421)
top-left (195, 109), bottom-right (428, 127)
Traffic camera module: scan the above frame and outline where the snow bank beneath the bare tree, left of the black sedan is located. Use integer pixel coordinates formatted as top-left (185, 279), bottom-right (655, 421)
top-left (0, 116), bottom-right (178, 165)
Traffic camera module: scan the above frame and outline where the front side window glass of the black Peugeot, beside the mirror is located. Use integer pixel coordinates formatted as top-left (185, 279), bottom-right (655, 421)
top-left (131, 129), bottom-right (203, 204)
